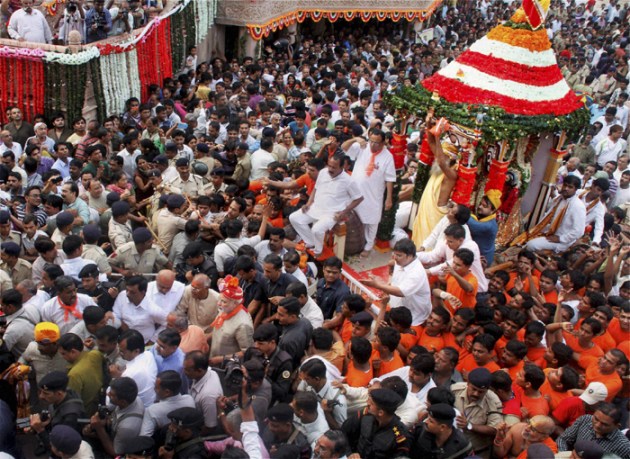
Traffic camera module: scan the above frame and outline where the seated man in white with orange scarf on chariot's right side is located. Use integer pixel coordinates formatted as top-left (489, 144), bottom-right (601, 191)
top-left (526, 175), bottom-right (586, 252)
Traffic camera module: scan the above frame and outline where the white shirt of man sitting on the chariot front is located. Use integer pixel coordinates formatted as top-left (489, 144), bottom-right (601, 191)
top-left (306, 167), bottom-right (361, 219)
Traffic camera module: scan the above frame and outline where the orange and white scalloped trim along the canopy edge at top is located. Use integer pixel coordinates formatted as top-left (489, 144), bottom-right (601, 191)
top-left (247, 0), bottom-right (442, 40)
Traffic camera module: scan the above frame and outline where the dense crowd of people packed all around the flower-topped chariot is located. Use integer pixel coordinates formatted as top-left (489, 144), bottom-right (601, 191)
top-left (0, 0), bottom-right (630, 459)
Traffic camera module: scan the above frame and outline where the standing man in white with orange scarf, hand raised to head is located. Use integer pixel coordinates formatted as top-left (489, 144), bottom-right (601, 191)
top-left (347, 129), bottom-right (396, 256)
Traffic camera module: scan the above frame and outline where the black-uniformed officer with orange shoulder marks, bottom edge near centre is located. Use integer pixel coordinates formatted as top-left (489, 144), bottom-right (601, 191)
top-left (341, 389), bottom-right (410, 459)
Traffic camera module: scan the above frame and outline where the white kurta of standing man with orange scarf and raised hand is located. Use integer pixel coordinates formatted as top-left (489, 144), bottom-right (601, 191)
top-left (348, 143), bottom-right (396, 225)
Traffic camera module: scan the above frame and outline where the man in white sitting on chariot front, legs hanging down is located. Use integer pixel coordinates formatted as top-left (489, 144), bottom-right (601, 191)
top-left (289, 155), bottom-right (363, 256)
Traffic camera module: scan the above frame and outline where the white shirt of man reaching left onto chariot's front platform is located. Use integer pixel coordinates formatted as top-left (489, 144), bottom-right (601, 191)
top-left (389, 259), bottom-right (431, 326)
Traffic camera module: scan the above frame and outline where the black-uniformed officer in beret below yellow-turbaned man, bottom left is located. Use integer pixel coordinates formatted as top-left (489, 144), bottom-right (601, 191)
top-left (30, 371), bottom-right (86, 456)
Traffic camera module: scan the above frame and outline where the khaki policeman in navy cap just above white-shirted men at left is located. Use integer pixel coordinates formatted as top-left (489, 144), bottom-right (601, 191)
top-left (109, 228), bottom-right (171, 277)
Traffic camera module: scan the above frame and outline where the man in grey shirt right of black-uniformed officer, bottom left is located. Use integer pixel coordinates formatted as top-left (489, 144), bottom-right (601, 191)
top-left (83, 377), bottom-right (144, 457)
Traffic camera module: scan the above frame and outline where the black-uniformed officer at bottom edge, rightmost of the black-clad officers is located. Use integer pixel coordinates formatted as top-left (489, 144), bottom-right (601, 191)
top-left (411, 403), bottom-right (472, 459)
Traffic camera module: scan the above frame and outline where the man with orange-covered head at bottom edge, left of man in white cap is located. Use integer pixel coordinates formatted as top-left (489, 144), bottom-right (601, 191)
top-left (493, 415), bottom-right (558, 459)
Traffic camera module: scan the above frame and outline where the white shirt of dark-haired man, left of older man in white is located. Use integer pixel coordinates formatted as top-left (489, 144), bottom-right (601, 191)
top-left (113, 292), bottom-right (168, 343)
